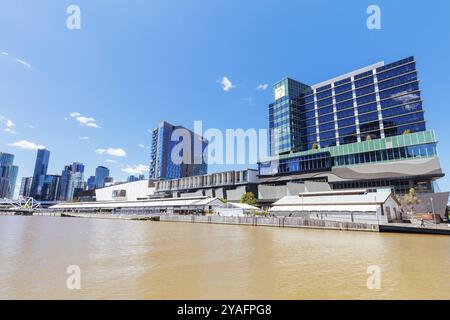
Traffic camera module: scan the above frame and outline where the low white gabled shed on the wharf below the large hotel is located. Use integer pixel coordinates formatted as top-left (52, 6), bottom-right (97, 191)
top-left (269, 189), bottom-right (402, 223)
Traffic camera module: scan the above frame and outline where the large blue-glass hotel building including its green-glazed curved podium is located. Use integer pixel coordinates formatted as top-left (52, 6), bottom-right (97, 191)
top-left (259, 57), bottom-right (444, 194)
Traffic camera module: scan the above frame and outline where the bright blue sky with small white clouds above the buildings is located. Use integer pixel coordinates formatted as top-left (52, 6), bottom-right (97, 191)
top-left (0, 0), bottom-right (450, 195)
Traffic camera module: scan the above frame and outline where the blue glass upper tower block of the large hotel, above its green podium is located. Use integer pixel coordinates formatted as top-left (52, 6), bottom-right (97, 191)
top-left (269, 57), bottom-right (426, 156)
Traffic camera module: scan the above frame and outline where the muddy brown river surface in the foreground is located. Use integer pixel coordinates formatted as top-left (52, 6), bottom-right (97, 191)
top-left (0, 216), bottom-right (450, 299)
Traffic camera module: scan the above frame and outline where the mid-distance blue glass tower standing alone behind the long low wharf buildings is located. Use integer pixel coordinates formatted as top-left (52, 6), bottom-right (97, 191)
top-left (149, 121), bottom-right (208, 180)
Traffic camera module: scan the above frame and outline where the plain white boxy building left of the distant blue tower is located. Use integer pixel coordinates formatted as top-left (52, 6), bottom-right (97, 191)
top-left (95, 180), bottom-right (155, 201)
